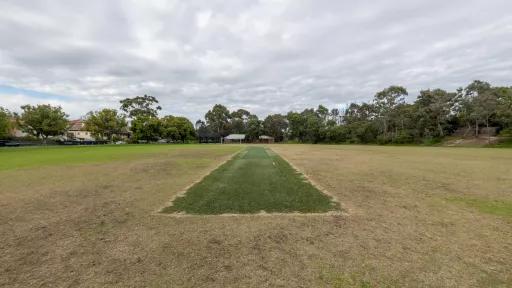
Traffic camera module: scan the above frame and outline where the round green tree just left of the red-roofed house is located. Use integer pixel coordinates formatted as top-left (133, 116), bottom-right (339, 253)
top-left (20, 105), bottom-right (69, 143)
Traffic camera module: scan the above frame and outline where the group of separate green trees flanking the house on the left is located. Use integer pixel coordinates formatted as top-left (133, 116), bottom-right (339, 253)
top-left (0, 95), bottom-right (196, 143)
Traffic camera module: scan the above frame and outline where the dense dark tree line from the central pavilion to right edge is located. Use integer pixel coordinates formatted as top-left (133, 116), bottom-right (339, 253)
top-left (196, 80), bottom-right (512, 144)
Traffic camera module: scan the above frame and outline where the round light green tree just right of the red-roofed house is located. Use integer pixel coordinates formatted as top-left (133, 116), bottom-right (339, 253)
top-left (85, 109), bottom-right (127, 141)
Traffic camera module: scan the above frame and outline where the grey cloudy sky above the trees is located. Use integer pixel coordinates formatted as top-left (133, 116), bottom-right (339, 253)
top-left (0, 0), bottom-right (512, 121)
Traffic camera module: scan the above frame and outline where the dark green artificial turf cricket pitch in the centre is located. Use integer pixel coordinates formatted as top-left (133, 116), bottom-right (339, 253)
top-left (162, 146), bottom-right (339, 215)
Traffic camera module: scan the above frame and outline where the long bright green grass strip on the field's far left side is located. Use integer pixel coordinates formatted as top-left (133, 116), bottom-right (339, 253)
top-left (0, 145), bottom-right (218, 170)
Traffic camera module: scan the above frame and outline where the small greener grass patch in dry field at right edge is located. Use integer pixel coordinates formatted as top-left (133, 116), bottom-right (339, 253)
top-left (447, 196), bottom-right (512, 217)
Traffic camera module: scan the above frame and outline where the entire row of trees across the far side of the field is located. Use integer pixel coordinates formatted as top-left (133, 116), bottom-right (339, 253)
top-left (0, 80), bottom-right (512, 144)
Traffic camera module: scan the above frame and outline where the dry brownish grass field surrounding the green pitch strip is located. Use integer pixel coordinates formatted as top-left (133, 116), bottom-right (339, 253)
top-left (0, 145), bottom-right (512, 287)
